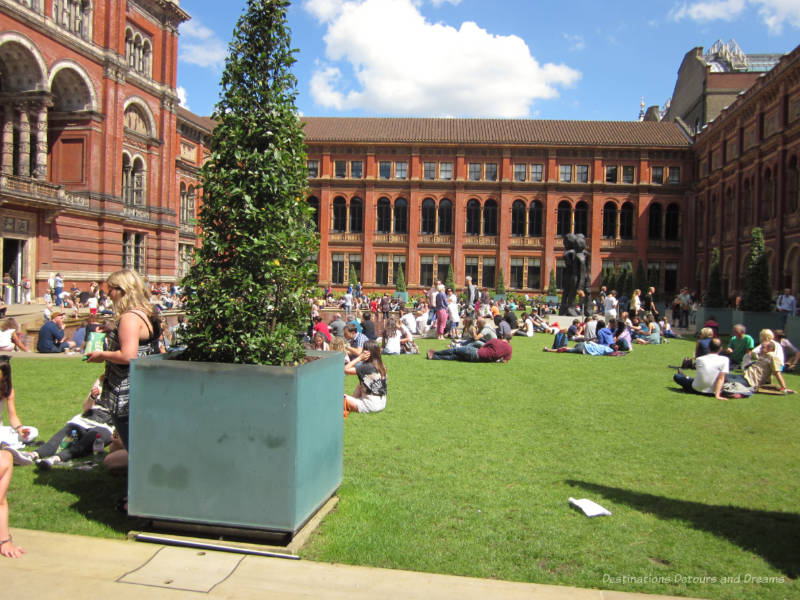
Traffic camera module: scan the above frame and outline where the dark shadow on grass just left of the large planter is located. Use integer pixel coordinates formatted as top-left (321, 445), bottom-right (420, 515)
top-left (34, 463), bottom-right (148, 535)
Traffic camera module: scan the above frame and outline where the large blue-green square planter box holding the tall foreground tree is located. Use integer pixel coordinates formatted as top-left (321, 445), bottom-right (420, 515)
top-left (128, 352), bottom-right (344, 534)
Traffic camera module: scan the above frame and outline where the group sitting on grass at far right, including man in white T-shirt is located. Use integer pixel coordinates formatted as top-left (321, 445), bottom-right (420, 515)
top-left (673, 324), bottom-right (800, 400)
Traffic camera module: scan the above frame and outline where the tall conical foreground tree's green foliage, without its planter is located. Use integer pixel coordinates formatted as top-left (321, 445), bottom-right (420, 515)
top-left (183, 0), bottom-right (318, 365)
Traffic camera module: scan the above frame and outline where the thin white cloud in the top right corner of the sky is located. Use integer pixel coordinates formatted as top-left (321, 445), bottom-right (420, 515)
top-left (669, 0), bottom-right (800, 34)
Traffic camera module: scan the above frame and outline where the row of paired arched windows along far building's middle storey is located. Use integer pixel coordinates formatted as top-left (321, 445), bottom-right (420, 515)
top-left (309, 196), bottom-right (680, 240)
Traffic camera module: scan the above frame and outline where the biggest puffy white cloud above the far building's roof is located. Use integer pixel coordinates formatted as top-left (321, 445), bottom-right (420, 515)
top-left (304, 0), bottom-right (580, 117)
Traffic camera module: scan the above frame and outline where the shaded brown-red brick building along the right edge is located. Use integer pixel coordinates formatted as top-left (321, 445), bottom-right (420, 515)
top-left (687, 47), bottom-right (800, 295)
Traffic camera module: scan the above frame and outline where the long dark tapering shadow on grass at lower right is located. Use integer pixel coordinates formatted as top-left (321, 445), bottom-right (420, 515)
top-left (566, 479), bottom-right (800, 579)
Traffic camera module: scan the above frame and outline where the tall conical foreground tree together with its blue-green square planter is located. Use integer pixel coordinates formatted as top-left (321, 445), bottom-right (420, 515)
top-left (128, 0), bottom-right (344, 535)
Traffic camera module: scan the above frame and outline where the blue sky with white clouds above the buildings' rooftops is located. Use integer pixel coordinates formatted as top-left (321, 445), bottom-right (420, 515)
top-left (178, 0), bottom-right (800, 120)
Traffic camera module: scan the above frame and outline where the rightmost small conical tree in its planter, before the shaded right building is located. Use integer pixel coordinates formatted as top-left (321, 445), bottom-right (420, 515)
top-left (733, 227), bottom-right (782, 337)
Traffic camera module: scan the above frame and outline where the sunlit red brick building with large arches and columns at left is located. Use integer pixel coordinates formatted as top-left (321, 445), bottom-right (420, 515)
top-left (0, 0), bottom-right (210, 295)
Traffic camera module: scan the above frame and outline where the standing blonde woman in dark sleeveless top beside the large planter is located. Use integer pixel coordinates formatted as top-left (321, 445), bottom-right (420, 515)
top-left (86, 269), bottom-right (161, 448)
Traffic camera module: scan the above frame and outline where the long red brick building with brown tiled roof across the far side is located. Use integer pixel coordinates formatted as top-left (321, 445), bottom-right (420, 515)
top-left (306, 118), bottom-right (694, 292)
